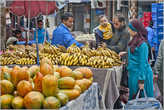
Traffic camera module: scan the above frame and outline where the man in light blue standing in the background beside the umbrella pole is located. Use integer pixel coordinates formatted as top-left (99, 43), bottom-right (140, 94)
top-left (34, 19), bottom-right (50, 44)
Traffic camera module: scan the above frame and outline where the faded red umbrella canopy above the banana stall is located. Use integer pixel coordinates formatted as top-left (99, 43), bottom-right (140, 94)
top-left (10, 0), bottom-right (57, 18)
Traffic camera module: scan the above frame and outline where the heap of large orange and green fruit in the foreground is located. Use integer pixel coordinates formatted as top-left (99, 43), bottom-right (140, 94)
top-left (0, 58), bottom-right (93, 109)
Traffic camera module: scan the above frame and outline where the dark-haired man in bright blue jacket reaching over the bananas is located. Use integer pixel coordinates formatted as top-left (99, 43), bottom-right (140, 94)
top-left (52, 12), bottom-right (83, 48)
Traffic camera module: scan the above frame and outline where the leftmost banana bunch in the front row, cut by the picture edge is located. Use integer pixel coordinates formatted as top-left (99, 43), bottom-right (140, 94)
top-left (0, 56), bottom-right (15, 65)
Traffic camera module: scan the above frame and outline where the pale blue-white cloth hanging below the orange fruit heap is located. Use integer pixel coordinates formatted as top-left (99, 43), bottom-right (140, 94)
top-left (59, 83), bottom-right (99, 110)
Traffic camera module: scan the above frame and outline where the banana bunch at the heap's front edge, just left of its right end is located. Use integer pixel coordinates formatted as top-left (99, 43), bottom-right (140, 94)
top-left (88, 56), bottom-right (114, 68)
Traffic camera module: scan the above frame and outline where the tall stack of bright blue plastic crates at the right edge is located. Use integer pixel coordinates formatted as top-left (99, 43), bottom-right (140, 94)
top-left (152, 2), bottom-right (164, 52)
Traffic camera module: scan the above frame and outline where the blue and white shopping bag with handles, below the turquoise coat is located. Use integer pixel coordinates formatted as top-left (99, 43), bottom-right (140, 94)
top-left (124, 90), bottom-right (162, 110)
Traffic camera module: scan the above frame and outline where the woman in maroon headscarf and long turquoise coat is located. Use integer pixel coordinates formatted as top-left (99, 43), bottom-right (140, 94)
top-left (127, 19), bottom-right (153, 99)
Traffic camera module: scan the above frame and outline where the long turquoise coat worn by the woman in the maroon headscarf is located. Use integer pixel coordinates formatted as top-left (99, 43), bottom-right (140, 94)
top-left (127, 42), bottom-right (153, 99)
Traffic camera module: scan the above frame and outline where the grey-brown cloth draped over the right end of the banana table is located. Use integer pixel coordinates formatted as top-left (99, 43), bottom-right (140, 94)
top-left (71, 66), bottom-right (122, 109)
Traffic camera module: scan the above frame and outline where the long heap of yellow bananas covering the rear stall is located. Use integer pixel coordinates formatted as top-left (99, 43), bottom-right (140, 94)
top-left (0, 43), bottom-right (122, 68)
